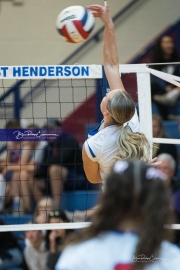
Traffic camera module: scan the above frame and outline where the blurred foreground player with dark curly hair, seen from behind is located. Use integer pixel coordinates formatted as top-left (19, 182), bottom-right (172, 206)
top-left (55, 160), bottom-right (180, 270)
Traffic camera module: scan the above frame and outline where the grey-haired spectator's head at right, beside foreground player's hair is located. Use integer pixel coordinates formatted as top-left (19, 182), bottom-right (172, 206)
top-left (157, 153), bottom-right (176, 182)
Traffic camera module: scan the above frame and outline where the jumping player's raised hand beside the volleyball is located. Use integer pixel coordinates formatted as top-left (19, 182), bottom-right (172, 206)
top-left (86, 5), bottom-right (111, 25)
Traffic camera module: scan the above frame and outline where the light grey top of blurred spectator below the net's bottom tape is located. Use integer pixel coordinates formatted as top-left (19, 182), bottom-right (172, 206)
top-left (23, 225), bottom-right (48, 270)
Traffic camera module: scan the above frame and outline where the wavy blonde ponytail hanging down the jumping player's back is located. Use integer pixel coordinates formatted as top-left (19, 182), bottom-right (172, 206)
top-left (118, 125), bottom-right (151, 162)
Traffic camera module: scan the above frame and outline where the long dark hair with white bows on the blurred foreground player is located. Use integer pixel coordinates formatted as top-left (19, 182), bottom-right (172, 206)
top-left (64, 160), bottom-right (172, 269)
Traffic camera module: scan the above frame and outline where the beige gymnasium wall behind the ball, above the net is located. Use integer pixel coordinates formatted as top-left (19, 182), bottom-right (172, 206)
top-left (0, 0), bottom-right (180, 65)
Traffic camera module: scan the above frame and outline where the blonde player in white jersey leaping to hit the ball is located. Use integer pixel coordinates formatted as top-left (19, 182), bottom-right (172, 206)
top-left (83, 5), bottom-right (150, 188)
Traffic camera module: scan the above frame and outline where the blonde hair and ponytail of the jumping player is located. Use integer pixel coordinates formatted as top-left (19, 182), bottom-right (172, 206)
top-left (107, 91), bottom-right (150, 162)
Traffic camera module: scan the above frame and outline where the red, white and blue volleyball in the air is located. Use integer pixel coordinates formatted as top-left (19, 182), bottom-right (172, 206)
top-left (56, 6), bottom-right (95, 43)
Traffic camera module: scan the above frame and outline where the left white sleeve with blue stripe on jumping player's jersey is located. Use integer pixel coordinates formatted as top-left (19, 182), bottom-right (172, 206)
top-left (84, 133), bottom-right (103, 162)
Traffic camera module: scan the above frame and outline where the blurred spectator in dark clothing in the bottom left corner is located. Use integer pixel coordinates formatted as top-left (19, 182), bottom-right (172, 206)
top-left (0, 219), bottom-right (23, 270)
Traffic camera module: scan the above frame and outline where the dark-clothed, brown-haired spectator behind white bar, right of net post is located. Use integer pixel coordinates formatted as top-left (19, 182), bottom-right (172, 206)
top-left (152, 114), bottom-right (178, 168)
